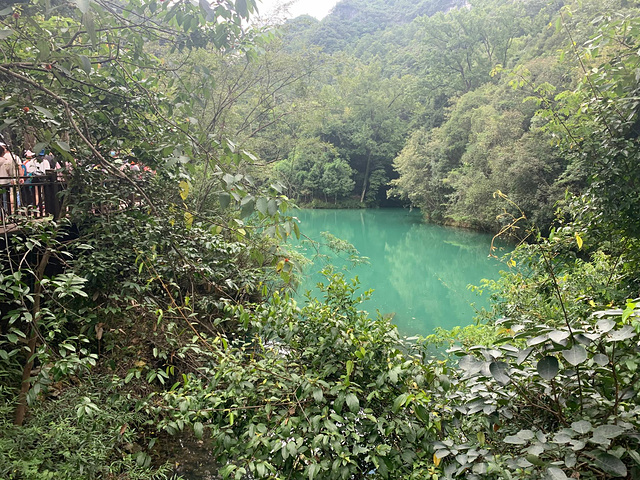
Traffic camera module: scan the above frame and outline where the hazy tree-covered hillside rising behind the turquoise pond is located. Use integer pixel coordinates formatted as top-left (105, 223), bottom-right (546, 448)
top-left (239, 0), bottom-right (636, 231)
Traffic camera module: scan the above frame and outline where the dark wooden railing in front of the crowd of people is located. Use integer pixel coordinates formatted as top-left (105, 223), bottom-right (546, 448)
top-left (0, 170), bottom-right (67, 218)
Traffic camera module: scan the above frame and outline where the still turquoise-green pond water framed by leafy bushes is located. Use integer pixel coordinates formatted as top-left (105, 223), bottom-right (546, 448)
top-left (295, 209), bottom-right (502, 336)
